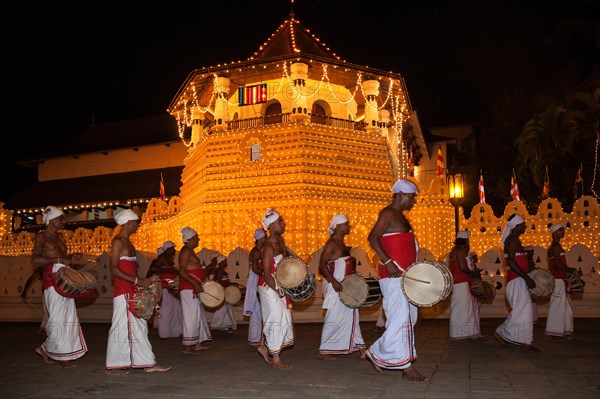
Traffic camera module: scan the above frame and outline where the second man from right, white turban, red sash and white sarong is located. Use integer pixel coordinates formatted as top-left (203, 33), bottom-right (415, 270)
top-left (494, 214), bottom-right (538, 352)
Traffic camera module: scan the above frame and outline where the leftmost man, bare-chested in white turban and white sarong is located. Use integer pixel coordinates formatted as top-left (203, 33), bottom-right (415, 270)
top-left (31, 206), bottom-right (87, 368)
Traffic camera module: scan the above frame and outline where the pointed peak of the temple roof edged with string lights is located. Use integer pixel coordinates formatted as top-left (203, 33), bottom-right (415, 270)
top-left (248, 14), bottom-right (340, 61)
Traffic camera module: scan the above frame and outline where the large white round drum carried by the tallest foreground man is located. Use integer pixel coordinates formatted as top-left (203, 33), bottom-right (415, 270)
top-left (401, 261), bottom-right (452, 307)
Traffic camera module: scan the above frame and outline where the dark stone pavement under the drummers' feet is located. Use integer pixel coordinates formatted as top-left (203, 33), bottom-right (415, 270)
top-left (0, 319), bottom-right (600, 399)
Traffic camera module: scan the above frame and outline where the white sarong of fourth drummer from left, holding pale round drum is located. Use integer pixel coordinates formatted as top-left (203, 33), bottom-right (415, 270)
top-left (179, 290), bottom-right (212, 346)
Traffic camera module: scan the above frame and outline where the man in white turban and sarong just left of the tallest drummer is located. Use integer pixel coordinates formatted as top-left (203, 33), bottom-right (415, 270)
top-left (319, 214), bottom-right (365, 360)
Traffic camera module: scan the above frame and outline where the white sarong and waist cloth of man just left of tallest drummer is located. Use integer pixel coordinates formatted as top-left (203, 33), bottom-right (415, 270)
top-left (319, 256), bottom-right (365, 354)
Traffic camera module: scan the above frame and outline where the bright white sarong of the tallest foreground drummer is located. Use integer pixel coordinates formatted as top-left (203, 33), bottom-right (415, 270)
top-left (367, 277), bottom-right (418, 369)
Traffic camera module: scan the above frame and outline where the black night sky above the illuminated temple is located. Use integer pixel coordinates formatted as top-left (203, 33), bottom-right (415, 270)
top-left (0, 0), bottom-right (599, 200)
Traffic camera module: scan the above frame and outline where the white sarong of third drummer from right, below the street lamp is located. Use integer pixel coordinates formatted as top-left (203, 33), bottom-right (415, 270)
top-left (449, 281), bottom-right (481, 339)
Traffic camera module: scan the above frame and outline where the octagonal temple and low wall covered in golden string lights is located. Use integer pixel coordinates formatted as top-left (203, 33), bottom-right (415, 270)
top-left (0, 15), bottom-right (600, 321)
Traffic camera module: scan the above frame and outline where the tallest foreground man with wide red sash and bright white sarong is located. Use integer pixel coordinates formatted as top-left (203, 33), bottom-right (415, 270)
top-left (366, 179), bottom-right (428, 382)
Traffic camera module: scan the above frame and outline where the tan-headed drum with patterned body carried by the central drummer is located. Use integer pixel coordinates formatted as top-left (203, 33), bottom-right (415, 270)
top-left (274, 256), bottom-right (317, 302)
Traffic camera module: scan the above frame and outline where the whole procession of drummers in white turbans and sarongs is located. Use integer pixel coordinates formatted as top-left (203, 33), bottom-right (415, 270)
top-left (25, 179), bottom-right (582, 382)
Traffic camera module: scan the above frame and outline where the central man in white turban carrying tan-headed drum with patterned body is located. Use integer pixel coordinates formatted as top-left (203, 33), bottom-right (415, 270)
top-left (257, 209), bottom-right (294, 369)
